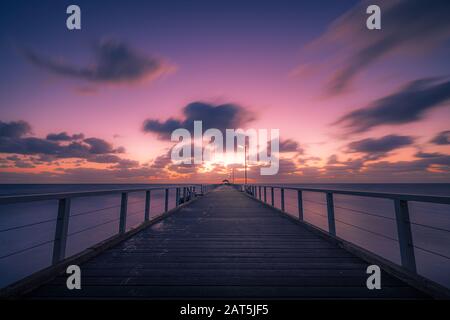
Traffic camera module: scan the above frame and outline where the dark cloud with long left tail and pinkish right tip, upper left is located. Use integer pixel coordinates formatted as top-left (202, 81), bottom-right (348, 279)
top-left (24, 39), bottom-right (173, 83)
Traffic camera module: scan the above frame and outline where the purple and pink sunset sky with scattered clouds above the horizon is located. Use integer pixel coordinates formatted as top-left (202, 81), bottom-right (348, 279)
top-left (0, 0), bottom-right (450, 183)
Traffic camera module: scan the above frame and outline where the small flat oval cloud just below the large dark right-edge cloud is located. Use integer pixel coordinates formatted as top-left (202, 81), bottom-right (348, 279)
top-left (348, 134), bottom-right (414, 155)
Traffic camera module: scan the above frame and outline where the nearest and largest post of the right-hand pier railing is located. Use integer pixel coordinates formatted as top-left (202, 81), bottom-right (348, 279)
top-left (394, 199), bottom-right (417, 273)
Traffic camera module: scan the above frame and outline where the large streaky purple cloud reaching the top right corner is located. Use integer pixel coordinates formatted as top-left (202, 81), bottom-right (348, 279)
top-left (298, 0), bottom-right (450, 94)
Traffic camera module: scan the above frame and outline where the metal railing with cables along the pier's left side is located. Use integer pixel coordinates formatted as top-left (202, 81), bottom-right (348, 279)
top-left (0, 185), bottom-right (212, 265)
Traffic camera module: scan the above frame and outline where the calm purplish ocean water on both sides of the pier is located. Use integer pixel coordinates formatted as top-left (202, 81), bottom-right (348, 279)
top-left (0, 183), bottom-right (450, 287)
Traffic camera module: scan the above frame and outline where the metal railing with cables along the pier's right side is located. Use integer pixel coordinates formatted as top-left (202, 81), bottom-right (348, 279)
top-left (241, 185), bottom-right (450, 274)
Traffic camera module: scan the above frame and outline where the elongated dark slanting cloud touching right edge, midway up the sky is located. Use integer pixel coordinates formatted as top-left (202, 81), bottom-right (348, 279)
top-left (333, 79), bottom-right (450, 133)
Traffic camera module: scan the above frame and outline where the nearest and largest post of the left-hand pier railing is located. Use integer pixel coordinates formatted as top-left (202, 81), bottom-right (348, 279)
top-left (52, 198), bottom-right (70, 264)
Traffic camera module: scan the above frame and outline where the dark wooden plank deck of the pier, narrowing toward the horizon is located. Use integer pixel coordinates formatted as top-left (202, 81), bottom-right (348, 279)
top-left (29, 187), bottom-right (426, 299)
